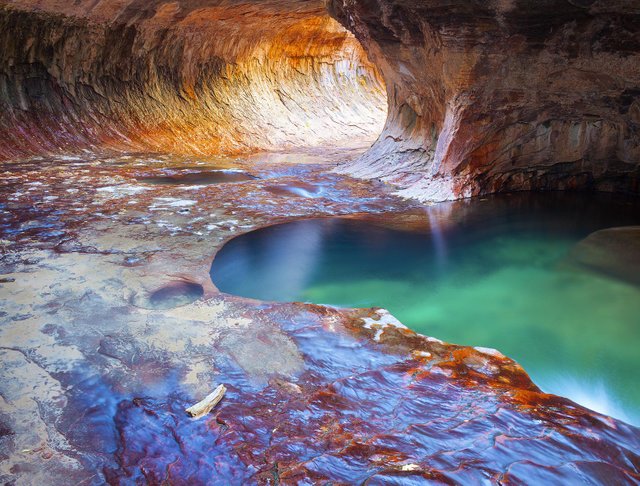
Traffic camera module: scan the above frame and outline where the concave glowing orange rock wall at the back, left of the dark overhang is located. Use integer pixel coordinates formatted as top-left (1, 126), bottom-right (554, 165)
top-left (0, 0), bottom-right (387, 159)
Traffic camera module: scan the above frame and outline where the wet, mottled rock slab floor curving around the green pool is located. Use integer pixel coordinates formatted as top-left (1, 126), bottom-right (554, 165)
top-left (0, 155), bottom-right (640, 485)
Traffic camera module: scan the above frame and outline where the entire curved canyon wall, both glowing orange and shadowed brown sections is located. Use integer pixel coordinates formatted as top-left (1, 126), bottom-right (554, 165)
top-left (0, 0), bottom-right (640, 201)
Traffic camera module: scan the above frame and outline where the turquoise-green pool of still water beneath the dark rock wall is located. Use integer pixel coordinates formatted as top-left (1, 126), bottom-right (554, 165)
top-left (211, 193), bottom-right (640, 424)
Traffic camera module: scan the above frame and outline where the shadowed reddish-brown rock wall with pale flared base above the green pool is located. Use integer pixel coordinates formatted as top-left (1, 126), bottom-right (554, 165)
top-left (328, 0), bottom-right (640, 200)
